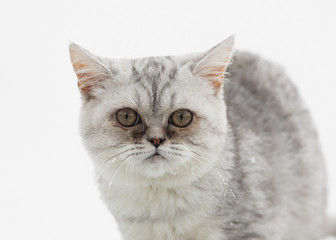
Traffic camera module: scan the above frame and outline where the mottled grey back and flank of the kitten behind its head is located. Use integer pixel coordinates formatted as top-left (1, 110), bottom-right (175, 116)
top-left (224, 52), bottom-right (325, 239)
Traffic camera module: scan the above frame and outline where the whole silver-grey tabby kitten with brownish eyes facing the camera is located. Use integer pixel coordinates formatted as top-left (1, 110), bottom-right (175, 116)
top-left (70, 37), bottom-right (325, 240)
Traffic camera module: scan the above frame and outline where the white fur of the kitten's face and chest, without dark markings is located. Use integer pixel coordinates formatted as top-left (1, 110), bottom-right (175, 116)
top-left (70, 38), bottom-right (240, 240)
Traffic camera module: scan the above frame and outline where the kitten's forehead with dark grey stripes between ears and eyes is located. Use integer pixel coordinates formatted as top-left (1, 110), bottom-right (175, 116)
top-left (107, 56), bottom-right (207, 115)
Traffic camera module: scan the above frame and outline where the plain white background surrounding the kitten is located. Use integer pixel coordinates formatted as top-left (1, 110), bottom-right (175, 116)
top-left (0, 0), bottom-right (336, 240)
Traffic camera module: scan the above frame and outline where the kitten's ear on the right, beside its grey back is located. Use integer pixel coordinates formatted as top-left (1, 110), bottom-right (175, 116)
top-left (193, 35), bottom-right (234, 92)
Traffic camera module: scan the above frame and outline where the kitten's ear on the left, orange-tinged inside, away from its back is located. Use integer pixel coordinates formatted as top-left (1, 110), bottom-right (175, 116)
top-left (69, 43), bottom-right (112, 98)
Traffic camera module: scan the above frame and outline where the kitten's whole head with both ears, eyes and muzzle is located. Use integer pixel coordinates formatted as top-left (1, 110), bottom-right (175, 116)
top-left (70, 37), bottom-right (234, 188)
